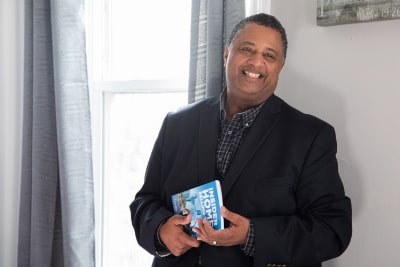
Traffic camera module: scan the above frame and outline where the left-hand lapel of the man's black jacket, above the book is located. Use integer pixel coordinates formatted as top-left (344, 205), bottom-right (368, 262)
top-left (198, 97), bottom-right (219, 184)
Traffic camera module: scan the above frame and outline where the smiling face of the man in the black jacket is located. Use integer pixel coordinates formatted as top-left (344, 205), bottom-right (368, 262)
top-left (224, 23), bottom-right (284, 105)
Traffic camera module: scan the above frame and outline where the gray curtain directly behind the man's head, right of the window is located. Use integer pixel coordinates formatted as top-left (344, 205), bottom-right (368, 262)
top-left (189, 0), bottom-right (245, 103)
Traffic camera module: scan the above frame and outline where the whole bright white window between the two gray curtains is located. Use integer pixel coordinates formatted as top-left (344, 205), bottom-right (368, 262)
top-left (87, 0), bottom-right (191, 267)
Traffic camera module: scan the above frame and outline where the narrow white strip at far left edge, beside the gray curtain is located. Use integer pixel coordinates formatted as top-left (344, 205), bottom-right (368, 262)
top-left (0, 0), bottom-right (23, 267)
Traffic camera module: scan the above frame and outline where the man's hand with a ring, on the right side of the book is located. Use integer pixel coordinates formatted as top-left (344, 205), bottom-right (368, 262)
top-left (193, 207), bottom-right (250, 249)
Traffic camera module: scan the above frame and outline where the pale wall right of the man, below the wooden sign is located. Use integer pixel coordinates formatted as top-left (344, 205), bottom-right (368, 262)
top-left (271, 0), bottom-right (400, 267)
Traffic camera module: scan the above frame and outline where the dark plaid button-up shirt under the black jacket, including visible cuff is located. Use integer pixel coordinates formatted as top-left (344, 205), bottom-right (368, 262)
top-left (217, 94), bottom-right (264, 256)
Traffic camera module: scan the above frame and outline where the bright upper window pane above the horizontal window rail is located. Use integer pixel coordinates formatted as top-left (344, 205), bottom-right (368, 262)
top-left (108, 0), bottom-right (191, 80)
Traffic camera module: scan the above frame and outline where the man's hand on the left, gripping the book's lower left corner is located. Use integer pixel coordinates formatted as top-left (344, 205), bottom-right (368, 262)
top-left (159, 214), bottom-right (200, 256)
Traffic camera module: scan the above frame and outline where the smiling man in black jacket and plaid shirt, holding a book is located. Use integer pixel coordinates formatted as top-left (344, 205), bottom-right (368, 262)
top-left (130, 14), bottom-right (352, 267)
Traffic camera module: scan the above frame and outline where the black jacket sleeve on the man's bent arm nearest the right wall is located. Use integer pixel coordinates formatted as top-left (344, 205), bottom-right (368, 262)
top-left (252, 124), bottom-right (352, 266)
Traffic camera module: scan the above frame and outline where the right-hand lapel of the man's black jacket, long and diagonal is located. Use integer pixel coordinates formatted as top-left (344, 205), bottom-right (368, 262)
top-left (222, 95), bottom-right (281, 197)
